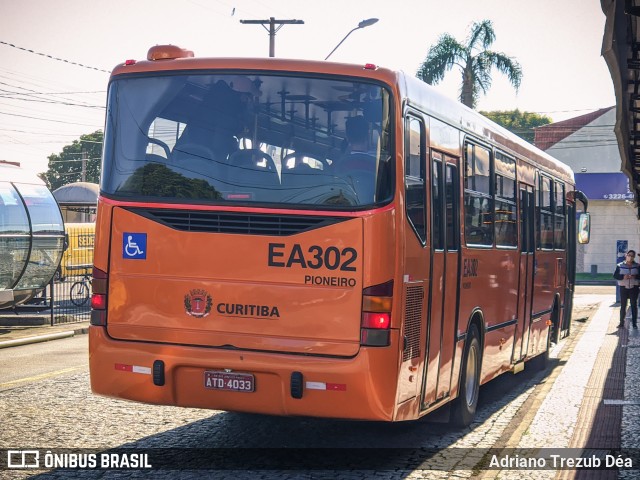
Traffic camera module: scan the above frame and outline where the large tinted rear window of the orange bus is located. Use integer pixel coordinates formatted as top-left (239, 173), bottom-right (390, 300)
top-left (101, 73), bottom-right (394, 210)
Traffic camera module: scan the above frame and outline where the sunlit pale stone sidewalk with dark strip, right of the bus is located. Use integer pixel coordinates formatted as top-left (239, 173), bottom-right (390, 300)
top-left (482, 287), bottom-right (640, 480)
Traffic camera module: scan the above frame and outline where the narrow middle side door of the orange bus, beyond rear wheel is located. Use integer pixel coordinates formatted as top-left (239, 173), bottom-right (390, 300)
top-left (511, 183), bottom-right (535, 363)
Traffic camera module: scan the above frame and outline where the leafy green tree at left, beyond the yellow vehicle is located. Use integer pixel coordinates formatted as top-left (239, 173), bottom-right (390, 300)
top-left (44, 130), bottom-right (103, 190)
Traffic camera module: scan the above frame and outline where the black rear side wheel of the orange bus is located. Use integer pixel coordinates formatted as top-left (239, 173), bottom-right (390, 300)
top-left (451, 325), bottom-right (482, 427)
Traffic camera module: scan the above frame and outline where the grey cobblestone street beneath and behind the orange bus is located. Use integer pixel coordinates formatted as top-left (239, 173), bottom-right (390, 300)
top-left (0, 366), bottom-right (542, 479)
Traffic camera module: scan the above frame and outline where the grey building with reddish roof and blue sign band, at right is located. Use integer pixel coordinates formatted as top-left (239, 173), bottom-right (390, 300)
top-left (534, 107), bottom-right (640, 273)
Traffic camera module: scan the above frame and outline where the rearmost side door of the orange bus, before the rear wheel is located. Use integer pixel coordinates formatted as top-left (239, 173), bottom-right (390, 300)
top-left (423, 152), bottom-right (460, 408)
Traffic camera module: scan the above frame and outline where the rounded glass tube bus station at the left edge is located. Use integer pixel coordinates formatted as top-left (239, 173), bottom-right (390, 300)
top-left (0, 163), bottom-right (65, 309)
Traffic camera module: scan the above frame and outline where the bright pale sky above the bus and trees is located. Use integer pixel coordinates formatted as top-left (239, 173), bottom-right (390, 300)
top-left (0, 0), bottom-right (615, 176)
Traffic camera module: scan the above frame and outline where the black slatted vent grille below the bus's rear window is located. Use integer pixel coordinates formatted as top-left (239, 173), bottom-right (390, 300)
top-left (127, 208), bottom-right (348, 236)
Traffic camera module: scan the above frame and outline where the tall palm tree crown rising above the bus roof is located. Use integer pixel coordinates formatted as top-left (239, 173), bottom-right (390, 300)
top-left (416, 20), bottom-right (522, 108)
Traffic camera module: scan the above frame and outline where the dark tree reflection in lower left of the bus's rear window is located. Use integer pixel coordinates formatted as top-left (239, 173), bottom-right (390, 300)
top-left (118, 163), bottom-right (222, 200)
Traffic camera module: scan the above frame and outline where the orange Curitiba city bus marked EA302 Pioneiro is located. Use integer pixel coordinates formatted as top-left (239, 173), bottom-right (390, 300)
top-left (89, 46), bottom-right (588, 424)
